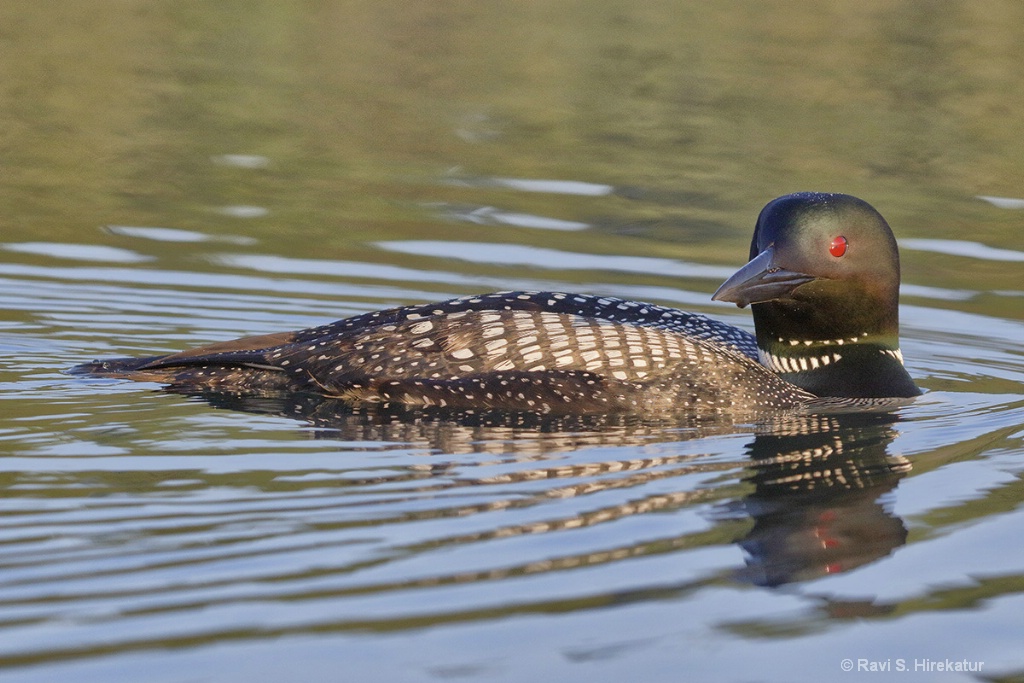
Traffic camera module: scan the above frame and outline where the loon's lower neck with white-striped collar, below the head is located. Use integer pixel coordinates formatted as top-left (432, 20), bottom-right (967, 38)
top-left (758, 335), bottom-right (921, 398)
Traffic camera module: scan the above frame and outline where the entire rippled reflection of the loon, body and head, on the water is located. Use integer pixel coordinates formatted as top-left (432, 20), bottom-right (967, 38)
top-left (180, 394), bottom-right (911, 589)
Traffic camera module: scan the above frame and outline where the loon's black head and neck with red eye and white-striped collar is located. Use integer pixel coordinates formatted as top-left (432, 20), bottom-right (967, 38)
top-left (713, 193), bottom-right (921, 397)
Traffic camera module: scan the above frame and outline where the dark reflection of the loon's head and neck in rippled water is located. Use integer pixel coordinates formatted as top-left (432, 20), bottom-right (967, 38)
top-left (739, 414), bottom-right (910, 586)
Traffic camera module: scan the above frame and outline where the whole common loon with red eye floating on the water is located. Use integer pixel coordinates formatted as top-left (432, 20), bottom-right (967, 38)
top-left (71, 193), bottom-right (921, 417)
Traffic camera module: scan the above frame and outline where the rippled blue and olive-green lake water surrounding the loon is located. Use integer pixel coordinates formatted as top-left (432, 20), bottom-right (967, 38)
top-left (0, 0), bottom-right (1024, 683)
